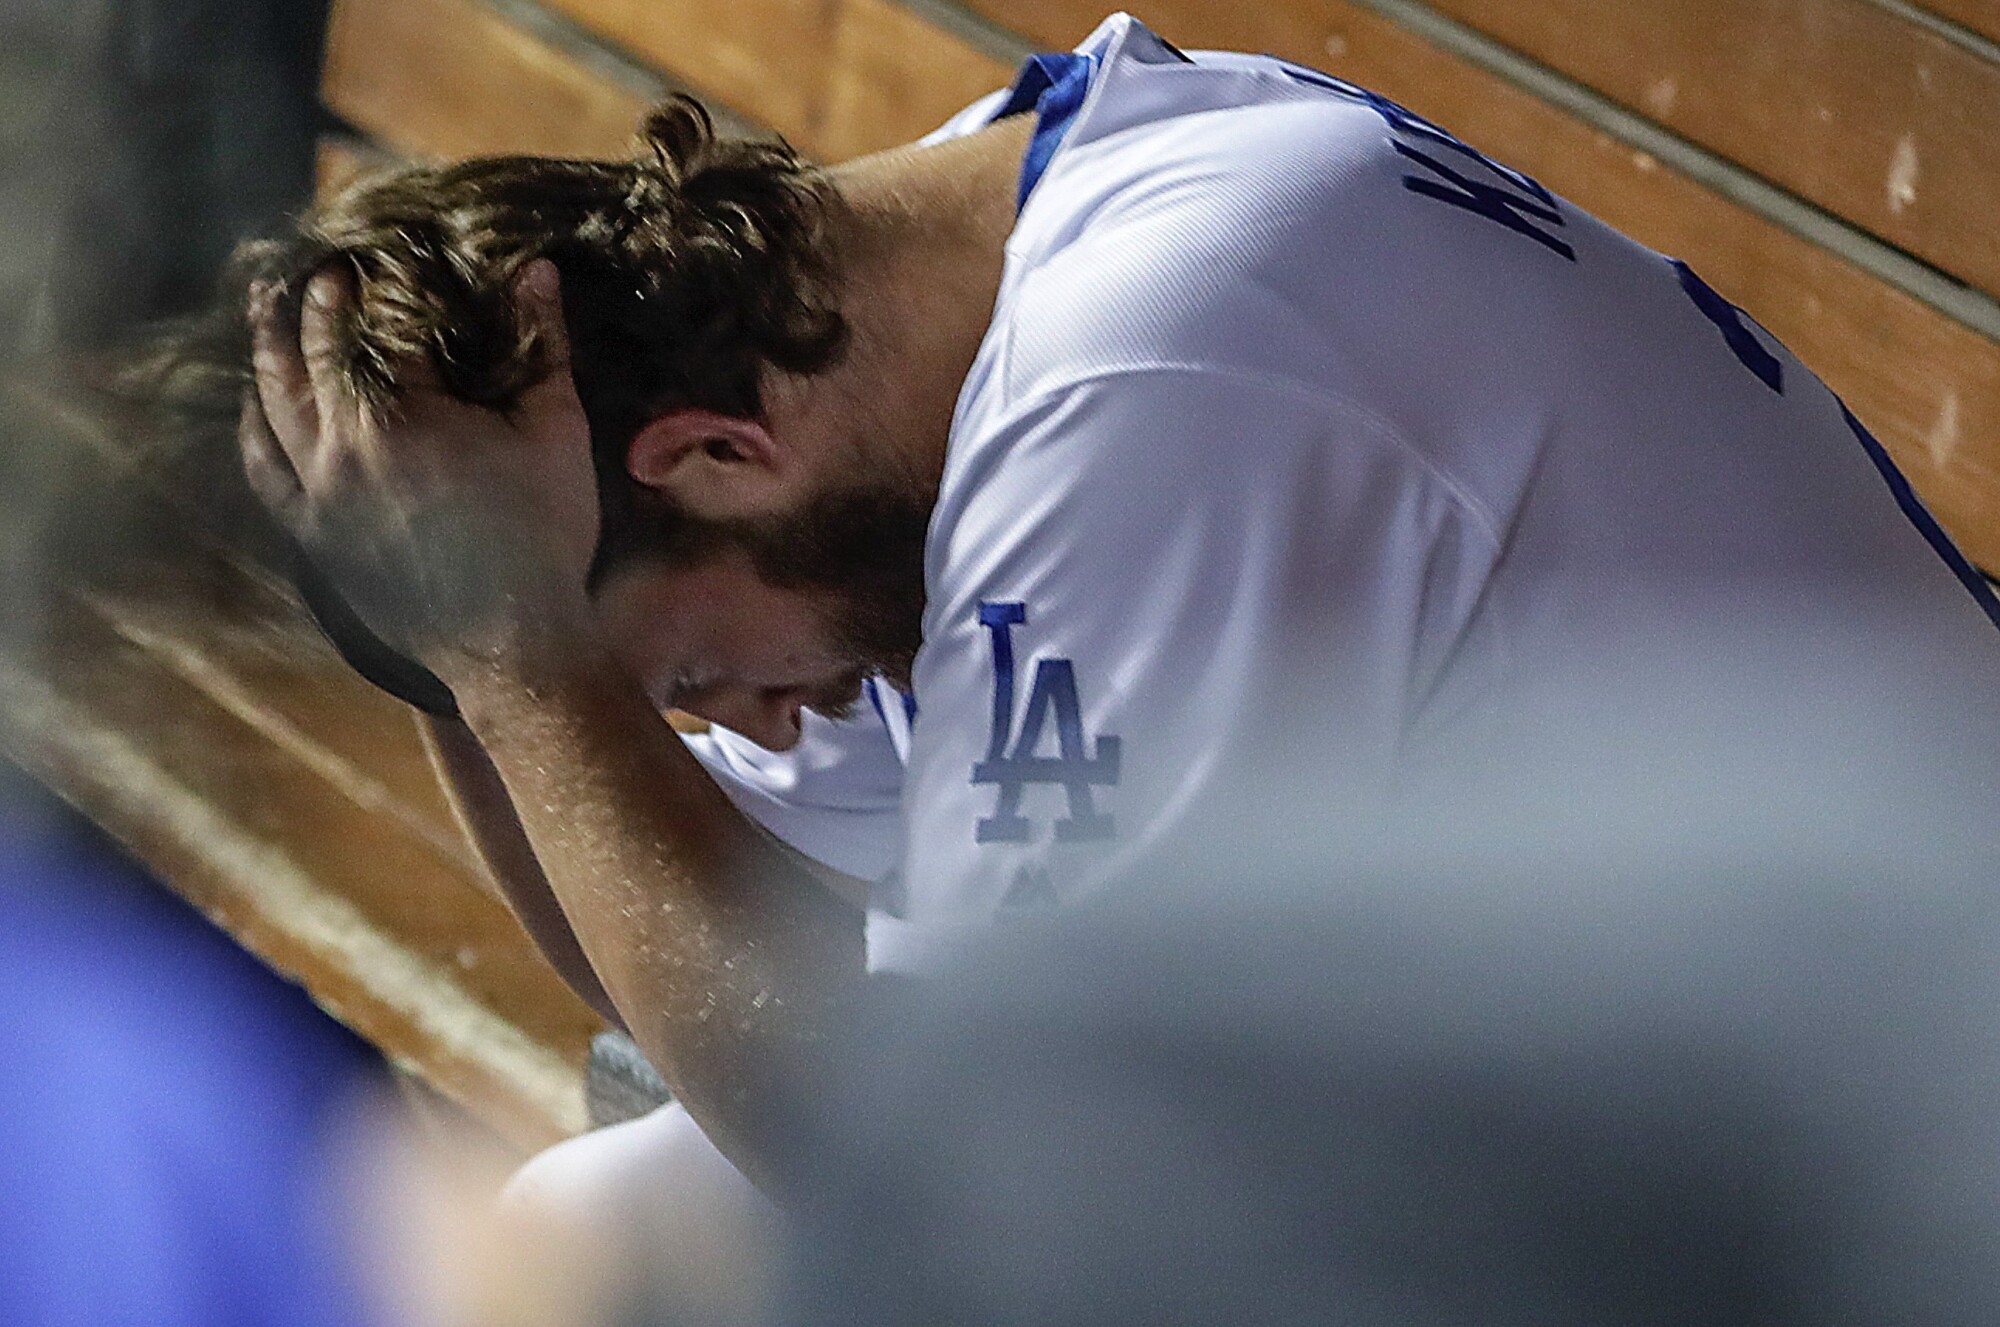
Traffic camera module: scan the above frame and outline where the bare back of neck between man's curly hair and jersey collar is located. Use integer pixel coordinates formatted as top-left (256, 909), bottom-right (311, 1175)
top-left (764, 116), bottom-right (1034, 508)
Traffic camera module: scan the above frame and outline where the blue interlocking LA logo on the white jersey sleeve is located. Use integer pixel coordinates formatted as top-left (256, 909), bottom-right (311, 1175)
top-left (972, 604), bottom-right (1118, 843)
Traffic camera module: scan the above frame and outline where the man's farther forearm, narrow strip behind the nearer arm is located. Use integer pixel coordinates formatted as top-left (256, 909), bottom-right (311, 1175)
top-left (418, 713), bottom-right (624, 1025)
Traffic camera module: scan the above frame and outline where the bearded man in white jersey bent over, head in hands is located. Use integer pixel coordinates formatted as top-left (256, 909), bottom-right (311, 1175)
top-left (188, 16), bottom-right (2000, 1195)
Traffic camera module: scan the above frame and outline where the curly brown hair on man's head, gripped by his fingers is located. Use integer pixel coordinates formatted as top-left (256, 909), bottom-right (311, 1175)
top-left (128, 96), bottom-right (846, 568)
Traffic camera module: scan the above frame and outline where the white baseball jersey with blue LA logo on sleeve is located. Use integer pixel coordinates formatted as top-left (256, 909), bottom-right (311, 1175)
top-left (684, 14), bottom-right (2000, 967)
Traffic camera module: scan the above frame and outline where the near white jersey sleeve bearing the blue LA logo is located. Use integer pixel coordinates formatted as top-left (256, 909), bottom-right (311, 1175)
top-left (870, 366), bottom-right (1494, 967)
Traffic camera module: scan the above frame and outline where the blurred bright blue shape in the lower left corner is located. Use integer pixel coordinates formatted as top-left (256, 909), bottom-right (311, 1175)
top-left (0, 771), bottom-right (380, 1327)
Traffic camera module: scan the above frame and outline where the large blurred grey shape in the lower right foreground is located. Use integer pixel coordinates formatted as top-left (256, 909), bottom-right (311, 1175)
top-left (792, 636), bottom-right (2000, 1327)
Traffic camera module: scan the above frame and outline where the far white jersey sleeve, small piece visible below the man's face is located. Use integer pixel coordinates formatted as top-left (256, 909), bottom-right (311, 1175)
top-left (682, 703), bottom-right (902, 881)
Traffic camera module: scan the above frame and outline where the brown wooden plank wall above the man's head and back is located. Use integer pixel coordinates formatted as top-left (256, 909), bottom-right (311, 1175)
top-left (326, 0), bottom-right (2000, 568)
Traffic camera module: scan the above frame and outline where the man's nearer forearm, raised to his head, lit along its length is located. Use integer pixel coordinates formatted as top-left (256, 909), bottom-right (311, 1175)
top-left (446, 632), bottom-right (862, 1189)
